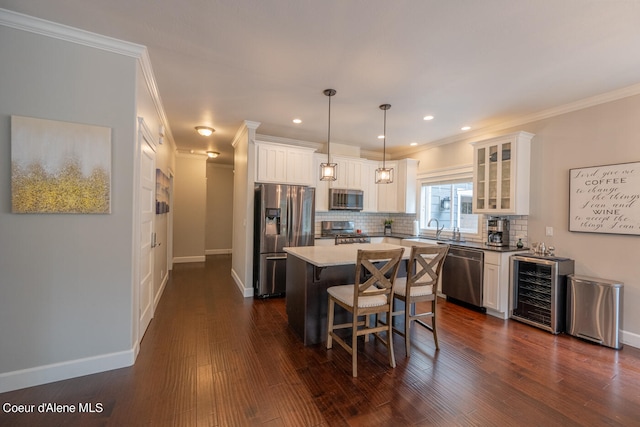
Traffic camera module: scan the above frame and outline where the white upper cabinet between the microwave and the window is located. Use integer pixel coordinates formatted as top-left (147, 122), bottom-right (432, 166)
top-left (375, 159), bottom-right (418, 214)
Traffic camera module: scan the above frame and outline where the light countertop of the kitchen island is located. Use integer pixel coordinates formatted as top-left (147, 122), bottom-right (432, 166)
top-left (284, 243), bottom-right (411, 267)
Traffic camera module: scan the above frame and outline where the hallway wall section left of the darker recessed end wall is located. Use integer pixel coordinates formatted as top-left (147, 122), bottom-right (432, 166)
top-left (173, 154), bottom-right (207, 262)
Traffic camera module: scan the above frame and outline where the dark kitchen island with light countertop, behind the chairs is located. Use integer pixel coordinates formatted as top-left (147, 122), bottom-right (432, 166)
top-left (284, 243), bottom-right (411, 345)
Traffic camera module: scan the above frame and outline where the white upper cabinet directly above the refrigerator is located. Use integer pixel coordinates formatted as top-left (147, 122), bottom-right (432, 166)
top-left (256, 141), bottom-right (319, 186)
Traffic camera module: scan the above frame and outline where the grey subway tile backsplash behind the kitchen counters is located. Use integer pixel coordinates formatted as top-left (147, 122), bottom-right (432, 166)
top-left (315, 211), bottom-right (529, 246)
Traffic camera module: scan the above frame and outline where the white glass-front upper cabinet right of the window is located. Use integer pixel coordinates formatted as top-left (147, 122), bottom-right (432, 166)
top-left (472, 132), bottom-right (534, 215)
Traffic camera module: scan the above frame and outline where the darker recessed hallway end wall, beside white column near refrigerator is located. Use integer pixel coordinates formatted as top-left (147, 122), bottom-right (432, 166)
top-left (205, 162), bottom-right (233, 255)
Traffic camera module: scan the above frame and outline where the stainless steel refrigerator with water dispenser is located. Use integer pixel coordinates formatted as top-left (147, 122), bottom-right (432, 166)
top-left (253, 184), bottom-right (315, 297)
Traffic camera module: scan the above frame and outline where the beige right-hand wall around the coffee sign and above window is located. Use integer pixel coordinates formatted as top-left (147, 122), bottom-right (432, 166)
top-left (411, 95), bottom-right (640, 347)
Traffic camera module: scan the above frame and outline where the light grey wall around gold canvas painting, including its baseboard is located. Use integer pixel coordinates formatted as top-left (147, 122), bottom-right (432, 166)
top-left (0, 16), bottom-right (137, 392)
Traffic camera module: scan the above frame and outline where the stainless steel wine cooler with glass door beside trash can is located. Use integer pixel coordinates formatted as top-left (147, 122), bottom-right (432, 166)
top-left (511, 255), bottom-right (574, 334)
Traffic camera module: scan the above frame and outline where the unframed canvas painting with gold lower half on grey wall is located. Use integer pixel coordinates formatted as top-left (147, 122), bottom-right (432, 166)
top-left (11, 116), bottom-right (111, 214)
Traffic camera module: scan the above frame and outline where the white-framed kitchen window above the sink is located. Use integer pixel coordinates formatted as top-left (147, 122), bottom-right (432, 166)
top-left (420, 169), bottom-right (480, 235)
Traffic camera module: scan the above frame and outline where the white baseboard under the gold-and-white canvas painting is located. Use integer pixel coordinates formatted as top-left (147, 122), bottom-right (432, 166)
top-left (0, 348), bottom-right (137, 393)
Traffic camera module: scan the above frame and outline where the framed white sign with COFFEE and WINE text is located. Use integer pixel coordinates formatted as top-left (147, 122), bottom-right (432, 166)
top-left (569, 162), bottom-right (640, 235)
